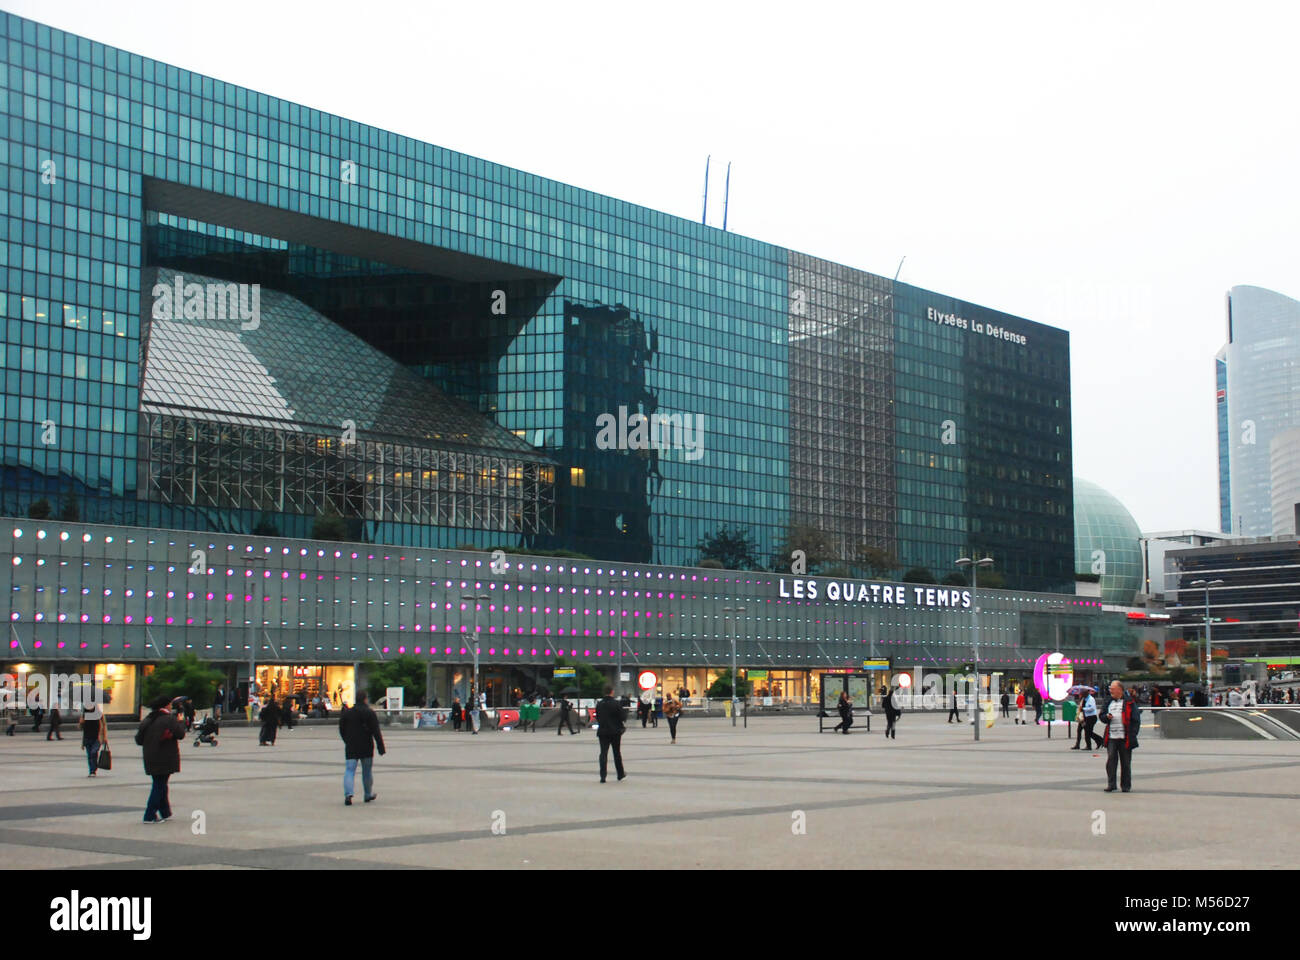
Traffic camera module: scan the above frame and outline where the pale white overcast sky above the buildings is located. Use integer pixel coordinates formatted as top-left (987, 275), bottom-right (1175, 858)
top-left (12, 0), bottom-right (1300, 531)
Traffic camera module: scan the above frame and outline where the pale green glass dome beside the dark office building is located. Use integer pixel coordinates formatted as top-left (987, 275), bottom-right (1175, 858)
top-left (1074, 477), bottom-right (1141, 604)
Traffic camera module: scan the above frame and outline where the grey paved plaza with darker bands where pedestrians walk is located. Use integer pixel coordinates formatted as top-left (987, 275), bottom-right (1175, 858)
top-left (0, 714), bottom-right (1300, 869)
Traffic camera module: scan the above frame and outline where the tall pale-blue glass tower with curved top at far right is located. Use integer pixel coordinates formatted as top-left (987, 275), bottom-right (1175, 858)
top-left (1216, 286), bottom-right (1300, 537)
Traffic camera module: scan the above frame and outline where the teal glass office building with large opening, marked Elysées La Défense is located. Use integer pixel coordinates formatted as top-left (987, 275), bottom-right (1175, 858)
top-left (0, 16), bottom-right (1071, 592)
